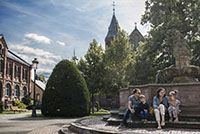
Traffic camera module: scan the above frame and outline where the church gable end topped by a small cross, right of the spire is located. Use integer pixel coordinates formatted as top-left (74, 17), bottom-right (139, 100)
top-left (129, 23), bottom-right (144, 50)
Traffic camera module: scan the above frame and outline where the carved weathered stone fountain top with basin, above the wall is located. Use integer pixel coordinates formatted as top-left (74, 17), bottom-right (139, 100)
top-left (156, 32), bottom-right (200, 83)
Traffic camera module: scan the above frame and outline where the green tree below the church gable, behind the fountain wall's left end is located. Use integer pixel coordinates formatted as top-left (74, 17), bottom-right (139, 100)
top-left (126, 42), bottom-right (155, 85)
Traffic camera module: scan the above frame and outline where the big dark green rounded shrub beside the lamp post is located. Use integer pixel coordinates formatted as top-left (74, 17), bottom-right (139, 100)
top-left (41, 60), bottom-right (89, 117)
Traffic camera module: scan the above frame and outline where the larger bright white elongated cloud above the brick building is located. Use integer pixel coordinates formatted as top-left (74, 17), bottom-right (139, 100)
top-left (25, 33), bottom-right (52, 44)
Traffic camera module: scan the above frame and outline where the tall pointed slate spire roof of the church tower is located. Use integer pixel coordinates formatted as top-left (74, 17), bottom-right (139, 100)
top-left (106, 14), bottom-right (120, 38)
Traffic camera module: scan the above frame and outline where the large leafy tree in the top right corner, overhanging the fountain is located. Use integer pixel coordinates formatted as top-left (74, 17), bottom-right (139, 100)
top-left (142, 0), bottom-right (200, 69)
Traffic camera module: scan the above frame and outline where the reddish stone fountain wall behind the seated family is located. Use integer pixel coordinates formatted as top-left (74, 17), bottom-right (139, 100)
top-left (119, 83), bottom-right (200, 116)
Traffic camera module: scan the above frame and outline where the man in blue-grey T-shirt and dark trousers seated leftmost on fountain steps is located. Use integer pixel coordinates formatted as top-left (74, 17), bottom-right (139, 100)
top-left (121, 88), bottom-right (141, 126)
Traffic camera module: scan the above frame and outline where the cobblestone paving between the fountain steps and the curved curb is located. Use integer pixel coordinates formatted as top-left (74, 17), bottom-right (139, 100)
top-left (81, 118), bottom-right (200, 134)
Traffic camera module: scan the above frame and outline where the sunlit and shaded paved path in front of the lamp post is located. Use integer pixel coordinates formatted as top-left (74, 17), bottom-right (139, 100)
top-left (0, 113), bottom-right (76, 134)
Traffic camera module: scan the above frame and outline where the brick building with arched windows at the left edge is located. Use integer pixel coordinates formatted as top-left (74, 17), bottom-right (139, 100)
top-left (0, 35), bottom-right (32, 109)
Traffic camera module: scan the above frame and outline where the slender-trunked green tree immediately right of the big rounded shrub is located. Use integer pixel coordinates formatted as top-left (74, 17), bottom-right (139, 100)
top-left (78, 40), bottom-right (104, 113)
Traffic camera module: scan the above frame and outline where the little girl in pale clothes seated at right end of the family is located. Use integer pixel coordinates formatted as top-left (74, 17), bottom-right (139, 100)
top-left (168, 90), bottom-right (180, 122)
